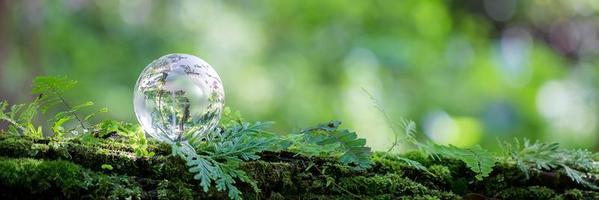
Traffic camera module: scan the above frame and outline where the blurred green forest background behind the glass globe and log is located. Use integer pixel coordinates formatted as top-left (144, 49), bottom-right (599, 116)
top-left (0, 0), bottom-right (599, 150)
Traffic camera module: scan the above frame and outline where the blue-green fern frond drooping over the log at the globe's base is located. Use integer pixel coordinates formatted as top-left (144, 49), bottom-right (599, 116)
top-left (172, 121), bottom-right (274, 199)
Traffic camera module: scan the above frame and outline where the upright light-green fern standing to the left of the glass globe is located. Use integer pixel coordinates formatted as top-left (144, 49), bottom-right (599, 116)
top-left (31, 76), bottom-right (108, 138)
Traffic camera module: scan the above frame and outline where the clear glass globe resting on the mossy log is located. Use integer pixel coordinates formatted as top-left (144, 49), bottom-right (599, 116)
top-left (133, 54), bottom-right (225, 142)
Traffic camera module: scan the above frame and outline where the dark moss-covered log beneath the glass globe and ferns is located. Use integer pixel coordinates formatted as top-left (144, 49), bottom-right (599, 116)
top-left (0, 134), bottom-right (599, 199)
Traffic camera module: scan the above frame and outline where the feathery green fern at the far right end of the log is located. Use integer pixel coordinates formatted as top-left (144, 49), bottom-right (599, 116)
top-left (500, 139), bottom-right (599, 189)
